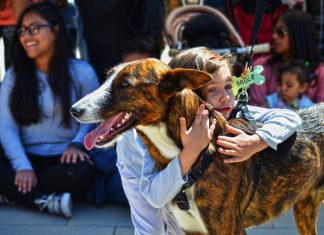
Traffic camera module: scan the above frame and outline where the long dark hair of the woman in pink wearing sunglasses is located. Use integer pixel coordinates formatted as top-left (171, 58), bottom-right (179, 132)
top-left (268, 10), bottom-right (319, 71)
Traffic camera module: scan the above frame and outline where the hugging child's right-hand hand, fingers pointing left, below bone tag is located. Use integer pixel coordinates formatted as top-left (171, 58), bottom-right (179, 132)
top-left (217, 124), bottom-right (268, 163)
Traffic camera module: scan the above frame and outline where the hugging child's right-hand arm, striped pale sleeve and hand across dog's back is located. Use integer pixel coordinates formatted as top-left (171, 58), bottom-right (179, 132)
top-left (217, 106), bottom-right (301, 163)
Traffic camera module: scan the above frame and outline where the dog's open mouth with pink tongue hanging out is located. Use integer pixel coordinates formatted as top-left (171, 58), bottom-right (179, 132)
top-left (84, 112), bottom-right (134, 150)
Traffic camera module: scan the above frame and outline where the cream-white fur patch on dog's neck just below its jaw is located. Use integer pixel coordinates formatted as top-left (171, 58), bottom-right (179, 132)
top-left (136, 123), bottom-right (180, 159)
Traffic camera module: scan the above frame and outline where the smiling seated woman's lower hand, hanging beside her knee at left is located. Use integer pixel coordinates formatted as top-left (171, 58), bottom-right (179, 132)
top-left (15, 170), bottom-right (37, 194)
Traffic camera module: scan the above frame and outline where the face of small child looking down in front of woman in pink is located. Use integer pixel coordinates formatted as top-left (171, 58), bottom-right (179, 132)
top-left (278, 72), bottom-right (307, 104)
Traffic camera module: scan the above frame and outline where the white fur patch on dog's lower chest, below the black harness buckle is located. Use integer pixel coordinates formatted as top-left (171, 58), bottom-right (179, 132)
top-left (170, 185), bottom-right (208, 234)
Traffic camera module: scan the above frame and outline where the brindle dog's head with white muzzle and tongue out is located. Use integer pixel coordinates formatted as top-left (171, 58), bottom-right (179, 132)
top-left (71, 59), bottom-right (212, 149)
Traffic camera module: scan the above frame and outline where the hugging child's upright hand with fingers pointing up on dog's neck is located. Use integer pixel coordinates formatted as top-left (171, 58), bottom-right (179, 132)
top-left (179, 104), bottom-right (216, 175)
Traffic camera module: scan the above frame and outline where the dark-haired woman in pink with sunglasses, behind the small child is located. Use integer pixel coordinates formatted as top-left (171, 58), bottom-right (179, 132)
top-left (250, 10), bottom-right (324, 106)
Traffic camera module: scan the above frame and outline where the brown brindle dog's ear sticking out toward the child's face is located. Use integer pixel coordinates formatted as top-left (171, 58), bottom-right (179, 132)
top-left (159, 68), bottom-right (212, 95)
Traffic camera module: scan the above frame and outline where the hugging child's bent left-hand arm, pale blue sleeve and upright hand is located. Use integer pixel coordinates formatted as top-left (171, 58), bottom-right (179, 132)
top-left (139, 105), bottom-right (216, 208)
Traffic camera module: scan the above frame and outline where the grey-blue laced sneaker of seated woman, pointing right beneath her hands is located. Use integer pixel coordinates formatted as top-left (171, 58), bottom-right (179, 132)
top-left (35, 193), bottom-right (72, 218)
